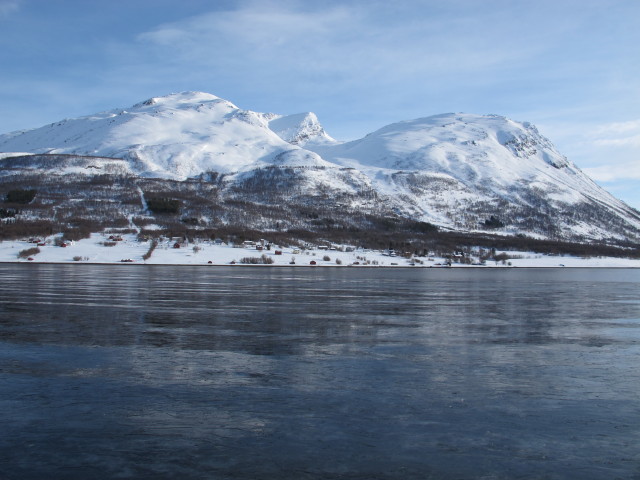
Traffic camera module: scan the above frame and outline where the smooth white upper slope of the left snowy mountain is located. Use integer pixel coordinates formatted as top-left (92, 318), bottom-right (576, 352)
top-left (0, 92), bottom-right (332, 179)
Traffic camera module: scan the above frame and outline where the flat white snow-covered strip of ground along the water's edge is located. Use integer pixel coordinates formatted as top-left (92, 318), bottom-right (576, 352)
top-left (0, 233), bottom-right (640, 268)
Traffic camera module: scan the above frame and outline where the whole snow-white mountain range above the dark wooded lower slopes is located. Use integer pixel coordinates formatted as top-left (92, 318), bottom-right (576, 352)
top-left (0, 91), bottom-right (640, 244)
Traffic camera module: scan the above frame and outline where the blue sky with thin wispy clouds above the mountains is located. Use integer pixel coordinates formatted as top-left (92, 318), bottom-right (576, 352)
top-left (0, 0), bottom-right (640, 209)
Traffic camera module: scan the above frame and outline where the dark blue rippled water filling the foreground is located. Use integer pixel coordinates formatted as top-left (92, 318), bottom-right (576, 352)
top-left (0, 265), bottom-right (640, 480)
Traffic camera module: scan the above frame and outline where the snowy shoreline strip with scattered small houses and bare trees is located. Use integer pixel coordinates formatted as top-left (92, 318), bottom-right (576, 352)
top-left (0, 233), bottom-right (640, 268)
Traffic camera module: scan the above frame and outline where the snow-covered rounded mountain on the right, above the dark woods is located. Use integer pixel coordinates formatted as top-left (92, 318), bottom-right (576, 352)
top-left (307, 114), bottom-right (640, 234)
